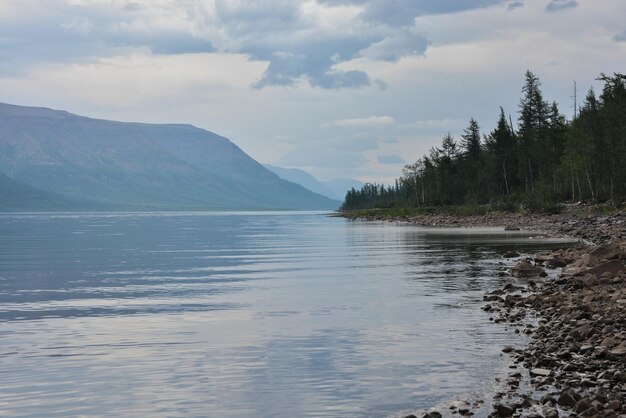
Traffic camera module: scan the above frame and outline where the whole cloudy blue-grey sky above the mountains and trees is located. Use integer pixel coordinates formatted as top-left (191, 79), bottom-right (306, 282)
top-left (0, 0), bottom-right (626, 182)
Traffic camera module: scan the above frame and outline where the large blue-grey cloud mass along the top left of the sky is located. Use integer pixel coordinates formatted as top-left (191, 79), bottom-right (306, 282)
top-left (0, 0), bottom-right (504, 90)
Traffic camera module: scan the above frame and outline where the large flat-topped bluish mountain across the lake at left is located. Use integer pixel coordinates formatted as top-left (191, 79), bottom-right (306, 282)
top-left (0, 103), bottom-right (340, 211)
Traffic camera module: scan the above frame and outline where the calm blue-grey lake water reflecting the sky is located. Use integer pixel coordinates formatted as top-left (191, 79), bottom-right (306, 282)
top-left (0, 212), bottom-right (572, 417)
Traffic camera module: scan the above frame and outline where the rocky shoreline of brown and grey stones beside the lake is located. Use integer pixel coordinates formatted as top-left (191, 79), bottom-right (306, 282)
top-left (344, 207), bottom-right (626, 418)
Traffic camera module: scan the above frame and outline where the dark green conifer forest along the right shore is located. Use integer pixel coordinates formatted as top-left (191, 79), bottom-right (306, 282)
top-left (342, 71), bottom-right (626, 210)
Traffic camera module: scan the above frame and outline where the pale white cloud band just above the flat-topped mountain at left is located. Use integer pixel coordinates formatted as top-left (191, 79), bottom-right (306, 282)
top-left (0, 51), bottom-right (265, 109)
